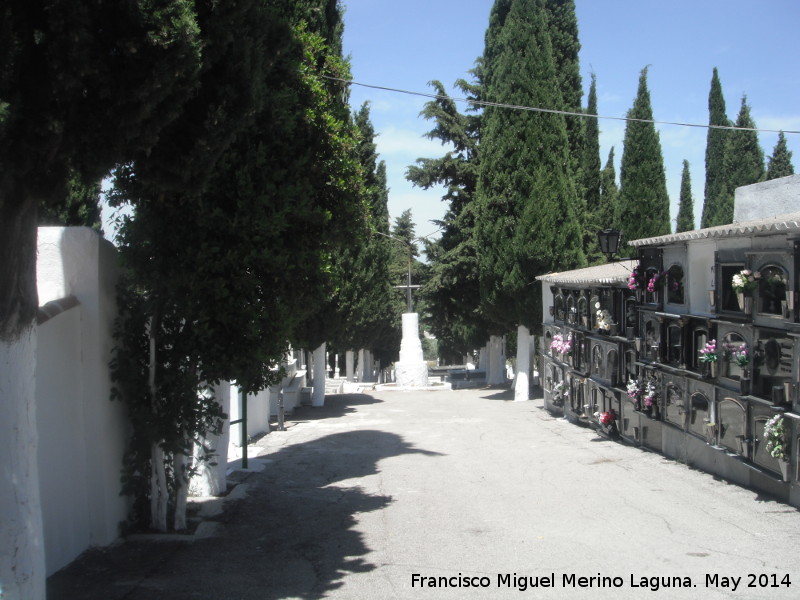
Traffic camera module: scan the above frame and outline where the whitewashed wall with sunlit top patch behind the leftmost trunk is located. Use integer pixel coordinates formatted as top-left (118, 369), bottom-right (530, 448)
top-left (36, 227), bottom-right (129, 575)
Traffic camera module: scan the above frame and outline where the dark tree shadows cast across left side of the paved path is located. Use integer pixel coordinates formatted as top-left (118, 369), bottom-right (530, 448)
top-left (47, 395), bottom-right (439, 600)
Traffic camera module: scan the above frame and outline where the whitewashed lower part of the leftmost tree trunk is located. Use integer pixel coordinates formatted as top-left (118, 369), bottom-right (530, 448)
top-left (0, 325), bottom-right (46, 600)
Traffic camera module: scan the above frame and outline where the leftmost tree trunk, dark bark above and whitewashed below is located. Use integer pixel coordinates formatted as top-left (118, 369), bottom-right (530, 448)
top-left (0, 196), bottom-right (46, 600)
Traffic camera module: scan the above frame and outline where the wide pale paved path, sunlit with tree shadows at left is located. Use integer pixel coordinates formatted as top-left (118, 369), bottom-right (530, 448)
top-left (48, 390), bottom-right (800, 600)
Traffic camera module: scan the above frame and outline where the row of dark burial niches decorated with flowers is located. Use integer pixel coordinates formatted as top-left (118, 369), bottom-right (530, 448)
top-left (543, 310), bottom-right (800, 486)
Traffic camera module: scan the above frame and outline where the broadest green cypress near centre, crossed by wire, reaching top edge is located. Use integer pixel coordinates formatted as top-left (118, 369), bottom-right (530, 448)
top-left (475, 0), bottom-right (585, 330)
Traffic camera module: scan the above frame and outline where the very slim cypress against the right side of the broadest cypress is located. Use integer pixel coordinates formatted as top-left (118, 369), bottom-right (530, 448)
top-left (578, 73), bottom-right (610, 263)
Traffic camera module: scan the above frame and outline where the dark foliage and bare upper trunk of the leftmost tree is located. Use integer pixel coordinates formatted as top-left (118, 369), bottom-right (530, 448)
top-left (0, 0), bottom-right (201, 338)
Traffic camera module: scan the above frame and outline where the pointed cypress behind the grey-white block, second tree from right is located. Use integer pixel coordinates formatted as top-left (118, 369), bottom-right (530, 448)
top-left (717, 96), bottom-right (765, 225)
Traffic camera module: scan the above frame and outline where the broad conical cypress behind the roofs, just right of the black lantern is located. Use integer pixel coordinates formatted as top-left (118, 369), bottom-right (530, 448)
top-left (619, 67), bottom-right (672, 250)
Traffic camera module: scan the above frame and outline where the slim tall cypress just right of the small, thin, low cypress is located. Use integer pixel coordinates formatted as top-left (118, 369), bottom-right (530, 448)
top-left (700, 67), bottom-right (731, 228)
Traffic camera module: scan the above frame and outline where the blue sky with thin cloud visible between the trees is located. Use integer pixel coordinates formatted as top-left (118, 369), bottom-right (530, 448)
top-left (342, 0), bottom-right (800, 241)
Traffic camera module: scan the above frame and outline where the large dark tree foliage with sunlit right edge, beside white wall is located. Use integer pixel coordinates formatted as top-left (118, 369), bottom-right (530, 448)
top-left (113, 0), bottom-right (364, 528)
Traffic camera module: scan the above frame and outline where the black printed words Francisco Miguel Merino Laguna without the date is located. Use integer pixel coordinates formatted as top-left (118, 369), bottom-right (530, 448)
top-left (411, 573), bottom-right (694, 592)
